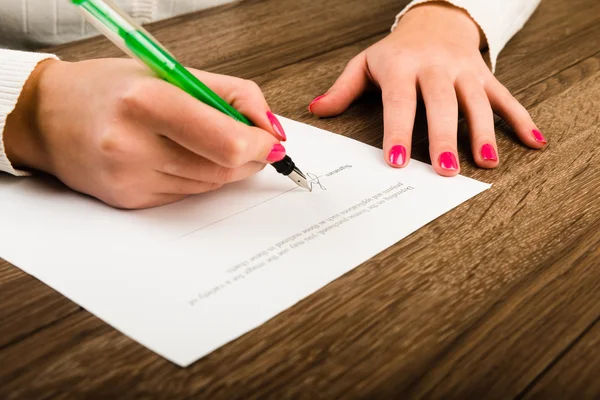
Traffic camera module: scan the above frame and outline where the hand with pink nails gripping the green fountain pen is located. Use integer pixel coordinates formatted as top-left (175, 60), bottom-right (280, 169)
top-left (4, 59), bottom-right (285, 209)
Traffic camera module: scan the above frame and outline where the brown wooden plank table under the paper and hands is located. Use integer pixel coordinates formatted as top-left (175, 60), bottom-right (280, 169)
top-left (0, 0), bottom-right (600, 399)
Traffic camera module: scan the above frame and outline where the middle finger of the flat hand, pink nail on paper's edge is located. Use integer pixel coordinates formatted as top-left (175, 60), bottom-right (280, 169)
top-left (418, 68), bottom-right (460, 176)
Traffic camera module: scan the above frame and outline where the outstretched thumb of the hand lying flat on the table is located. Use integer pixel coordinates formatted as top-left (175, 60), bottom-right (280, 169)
top-left (308, 52), bottom-right (370, 117)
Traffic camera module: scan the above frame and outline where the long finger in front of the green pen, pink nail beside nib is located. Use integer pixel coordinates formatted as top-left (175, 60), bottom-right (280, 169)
top-left (123, 79), bottom-right (285, 168)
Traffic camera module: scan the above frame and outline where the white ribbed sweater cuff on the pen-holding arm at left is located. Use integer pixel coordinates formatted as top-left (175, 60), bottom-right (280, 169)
top-left (0, 49), bottom-right (56, 176)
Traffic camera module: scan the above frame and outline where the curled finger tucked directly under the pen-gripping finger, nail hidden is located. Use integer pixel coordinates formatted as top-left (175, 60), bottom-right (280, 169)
top-left (156, 136), bottom-right (265, 184)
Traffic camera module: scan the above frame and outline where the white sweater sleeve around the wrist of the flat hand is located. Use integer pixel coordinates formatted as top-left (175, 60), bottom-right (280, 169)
top-left (392, 0), bottom-right (541, 72)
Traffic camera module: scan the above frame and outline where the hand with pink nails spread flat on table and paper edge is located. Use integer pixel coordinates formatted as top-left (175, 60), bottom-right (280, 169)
top-left (309, 2), bottom-right (546, 176)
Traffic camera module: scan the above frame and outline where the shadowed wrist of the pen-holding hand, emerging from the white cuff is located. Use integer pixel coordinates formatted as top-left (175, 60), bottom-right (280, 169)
top-left (3, 59), bottom-right (60, 172)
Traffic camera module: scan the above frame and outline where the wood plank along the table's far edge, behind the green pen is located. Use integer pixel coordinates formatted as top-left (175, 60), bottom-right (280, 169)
top-left (49, 0), bottom-right (409, 78)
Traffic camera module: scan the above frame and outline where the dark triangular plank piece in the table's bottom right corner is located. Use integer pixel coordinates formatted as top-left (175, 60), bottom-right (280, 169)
top-left (524, 318), bottom-right (600, 399)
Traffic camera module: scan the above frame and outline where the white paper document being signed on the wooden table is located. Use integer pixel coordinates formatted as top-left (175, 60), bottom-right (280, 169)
top-left (0, 117), bottom-right (489, 366)
